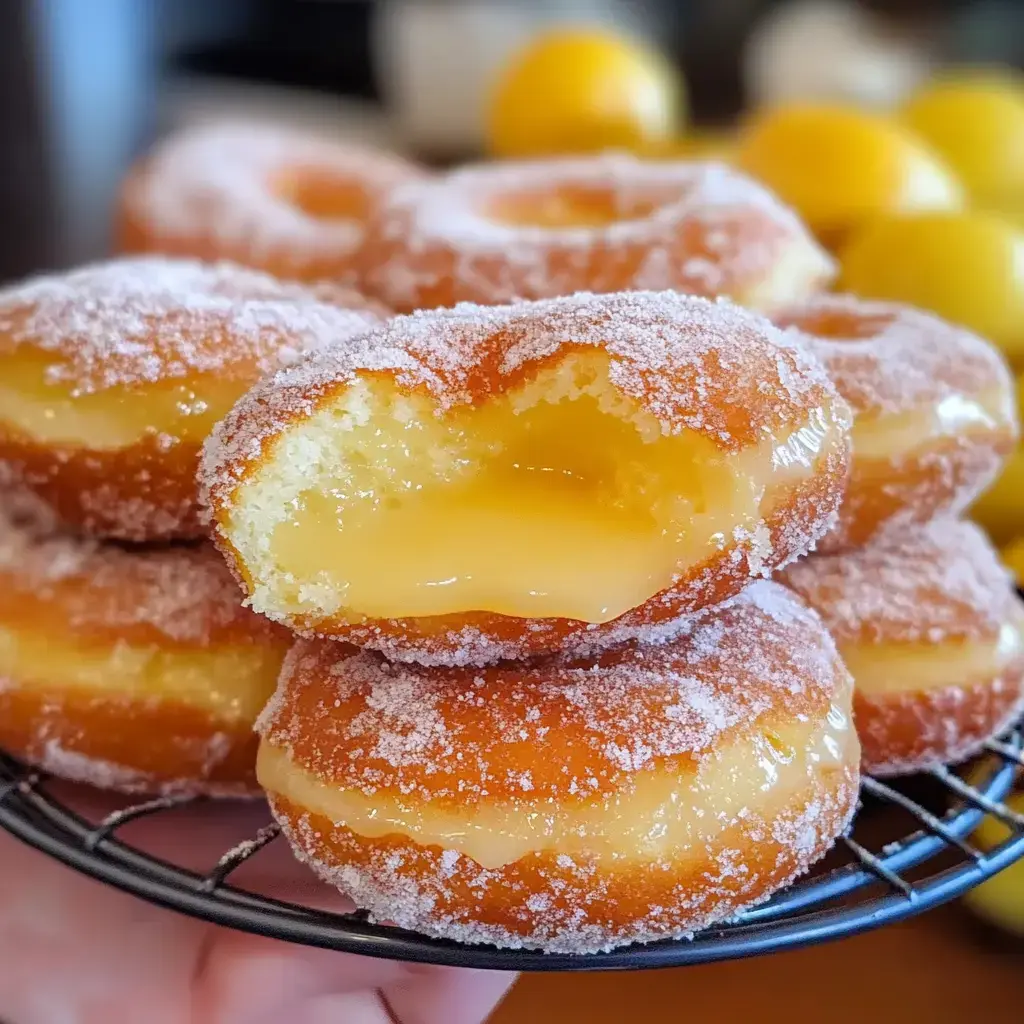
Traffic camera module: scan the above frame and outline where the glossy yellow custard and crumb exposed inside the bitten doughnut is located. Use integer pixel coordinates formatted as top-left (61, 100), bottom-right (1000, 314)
top-left (260, 356), bottom-right (827, 623)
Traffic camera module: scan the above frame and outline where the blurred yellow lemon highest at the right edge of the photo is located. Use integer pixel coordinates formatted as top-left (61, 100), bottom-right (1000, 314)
top-left (902, 72), bottom-right (1024, 207)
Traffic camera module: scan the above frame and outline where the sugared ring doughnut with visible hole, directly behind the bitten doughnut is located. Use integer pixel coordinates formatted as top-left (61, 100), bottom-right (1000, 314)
top-left (359, 154), bottom-right (834, 312)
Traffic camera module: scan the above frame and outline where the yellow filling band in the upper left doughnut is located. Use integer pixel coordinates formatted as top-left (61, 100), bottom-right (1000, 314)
top-left (0, 354), bottom-right (245, 452)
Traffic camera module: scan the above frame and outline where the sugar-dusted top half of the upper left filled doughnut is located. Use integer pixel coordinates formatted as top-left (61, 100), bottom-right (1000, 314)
top-left (0, 256), bottom-right (385, 394)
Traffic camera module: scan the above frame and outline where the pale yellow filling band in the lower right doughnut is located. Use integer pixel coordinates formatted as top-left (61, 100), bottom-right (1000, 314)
top-left (840, 623), bottom-right (1024, 694)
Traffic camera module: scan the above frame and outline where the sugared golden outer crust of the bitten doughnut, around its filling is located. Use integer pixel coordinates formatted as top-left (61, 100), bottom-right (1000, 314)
top-left (201, 292), bottom-right (850, 665)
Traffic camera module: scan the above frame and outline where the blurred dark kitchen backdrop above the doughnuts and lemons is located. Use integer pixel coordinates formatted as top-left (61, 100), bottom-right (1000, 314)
top-left (6, 0), bottom-right (1024, 280)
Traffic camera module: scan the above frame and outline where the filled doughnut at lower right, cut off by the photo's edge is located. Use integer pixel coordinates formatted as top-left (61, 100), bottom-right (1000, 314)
top-left (782, 520), bottom-right (1024, 775)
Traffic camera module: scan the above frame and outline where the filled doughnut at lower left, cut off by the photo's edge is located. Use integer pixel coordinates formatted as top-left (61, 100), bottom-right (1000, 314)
top-left (0, 517), bottom-right (291, 795)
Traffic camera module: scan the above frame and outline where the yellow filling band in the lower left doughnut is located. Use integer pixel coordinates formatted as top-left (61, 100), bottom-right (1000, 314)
top-left (0, 626), bottom-right (284, 723)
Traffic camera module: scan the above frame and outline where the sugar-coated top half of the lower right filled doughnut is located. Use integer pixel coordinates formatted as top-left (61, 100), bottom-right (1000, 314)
top-left (781, 518), bottom-right (1021, 645)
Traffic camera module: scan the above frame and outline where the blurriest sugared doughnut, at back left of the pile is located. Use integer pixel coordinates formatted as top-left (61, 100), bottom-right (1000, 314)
top-left (117, 123), bottom-right (424, 281)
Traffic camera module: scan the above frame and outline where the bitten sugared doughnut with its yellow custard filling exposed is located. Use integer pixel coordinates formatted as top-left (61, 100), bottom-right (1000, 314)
top-left (203, 292), bottom-right (849, 665)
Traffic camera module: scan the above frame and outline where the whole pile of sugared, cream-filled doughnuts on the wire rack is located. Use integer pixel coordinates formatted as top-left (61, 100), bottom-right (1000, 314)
top-left (0, 125), bottom-right (1024, 953)
